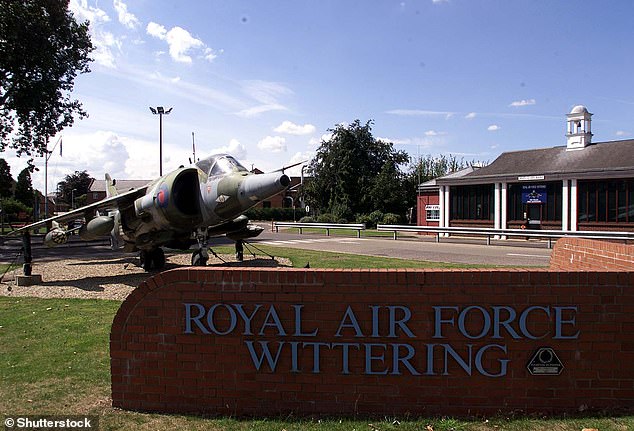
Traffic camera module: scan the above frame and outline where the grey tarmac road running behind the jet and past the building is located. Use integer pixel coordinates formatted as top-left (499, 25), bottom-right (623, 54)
top-left (0, 225), bottom-right (551, 266)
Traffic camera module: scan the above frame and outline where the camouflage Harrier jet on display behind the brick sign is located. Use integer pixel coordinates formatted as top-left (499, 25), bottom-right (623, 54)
top-left (12, 154), bottom-right (296, 270)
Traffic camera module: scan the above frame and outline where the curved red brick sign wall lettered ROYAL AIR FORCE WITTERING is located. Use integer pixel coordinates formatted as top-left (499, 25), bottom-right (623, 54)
top-left (110, 268), bottom-right (634, 416)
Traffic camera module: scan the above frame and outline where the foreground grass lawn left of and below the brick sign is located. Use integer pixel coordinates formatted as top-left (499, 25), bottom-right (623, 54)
top-left (0, 297), bottom-right (634, 431)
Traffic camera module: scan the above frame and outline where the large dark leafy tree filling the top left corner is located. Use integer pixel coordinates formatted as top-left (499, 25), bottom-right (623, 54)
top-left (0, 0), bottom-right (93, 156)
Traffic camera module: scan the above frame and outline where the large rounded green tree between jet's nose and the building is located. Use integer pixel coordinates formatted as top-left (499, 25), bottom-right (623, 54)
top-left (304, 120), bottom-right (409, 220)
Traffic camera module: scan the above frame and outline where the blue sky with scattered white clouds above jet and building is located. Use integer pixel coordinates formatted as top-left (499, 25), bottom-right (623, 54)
top-left (0, 0), bottom-right (634, 192)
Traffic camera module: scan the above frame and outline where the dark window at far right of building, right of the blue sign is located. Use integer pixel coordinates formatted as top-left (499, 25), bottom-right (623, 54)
top-left (577, 180), bottom-right (634, 223)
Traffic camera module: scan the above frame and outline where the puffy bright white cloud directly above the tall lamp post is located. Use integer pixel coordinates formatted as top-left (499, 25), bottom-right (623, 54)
top-left (145, 21), bottom-right (217, 64)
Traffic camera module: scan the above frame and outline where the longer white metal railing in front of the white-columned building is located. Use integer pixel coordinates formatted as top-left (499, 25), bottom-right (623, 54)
top-left (377, 224), bottom-right (634, 248)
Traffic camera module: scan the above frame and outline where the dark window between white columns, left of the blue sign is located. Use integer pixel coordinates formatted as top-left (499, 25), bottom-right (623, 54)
top-left (449, 184), bottom-right (493, 220)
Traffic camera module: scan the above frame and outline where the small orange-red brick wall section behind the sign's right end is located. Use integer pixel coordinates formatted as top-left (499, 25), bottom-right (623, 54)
top-left (550, 238), bottom-right (634, 271)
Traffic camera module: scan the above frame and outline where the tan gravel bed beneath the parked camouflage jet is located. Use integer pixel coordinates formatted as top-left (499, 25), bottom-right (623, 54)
top-left (0, 254), bottom-right (292, 301)
